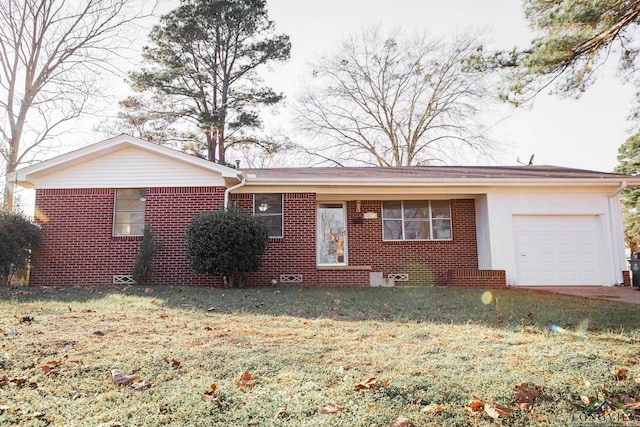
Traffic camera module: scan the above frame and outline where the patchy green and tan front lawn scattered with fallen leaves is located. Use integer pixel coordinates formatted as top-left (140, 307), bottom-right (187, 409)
top-left (0, 287), bottom-right (640, 427)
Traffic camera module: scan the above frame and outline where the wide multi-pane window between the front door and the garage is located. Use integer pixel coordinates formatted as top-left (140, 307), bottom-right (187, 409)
top-left (382, 200), bottom-right (453, 240)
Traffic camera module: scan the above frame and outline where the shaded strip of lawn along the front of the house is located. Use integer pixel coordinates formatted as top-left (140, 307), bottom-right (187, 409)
top-left (0, 286), bottom-right (640, 334)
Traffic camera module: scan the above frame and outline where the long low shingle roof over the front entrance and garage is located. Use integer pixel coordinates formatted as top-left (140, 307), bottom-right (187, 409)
top-left (242, 165), bottom-right (629, 181)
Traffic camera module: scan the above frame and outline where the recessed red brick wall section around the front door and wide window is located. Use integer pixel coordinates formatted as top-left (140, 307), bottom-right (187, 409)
top-left (238, 193), bottom-right (478, 286)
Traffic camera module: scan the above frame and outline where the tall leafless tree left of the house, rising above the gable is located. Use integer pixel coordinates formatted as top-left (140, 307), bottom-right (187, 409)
top-left (0, 0), bottom-right (154, 210)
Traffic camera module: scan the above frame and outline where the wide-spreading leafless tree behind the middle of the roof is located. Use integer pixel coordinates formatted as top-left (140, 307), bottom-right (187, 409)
top-left (296, 28), bottom-right (490, 166)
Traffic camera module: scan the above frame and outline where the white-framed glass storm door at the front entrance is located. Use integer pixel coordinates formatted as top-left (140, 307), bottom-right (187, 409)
top-left (316, 203), bottom-right (347, 265)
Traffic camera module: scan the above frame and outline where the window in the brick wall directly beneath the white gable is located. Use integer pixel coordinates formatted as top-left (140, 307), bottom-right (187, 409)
top-left (113, 188), bottom-right (147, 236)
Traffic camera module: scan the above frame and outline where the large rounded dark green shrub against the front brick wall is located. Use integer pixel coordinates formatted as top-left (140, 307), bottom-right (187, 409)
top-left (185, 209), bottom-right (269, 286)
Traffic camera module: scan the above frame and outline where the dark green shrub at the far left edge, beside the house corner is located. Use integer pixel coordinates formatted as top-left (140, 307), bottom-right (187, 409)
top-left (0, 212), bottom-right (40, 285)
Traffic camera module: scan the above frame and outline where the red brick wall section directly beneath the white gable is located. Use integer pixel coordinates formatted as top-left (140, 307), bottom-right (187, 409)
top-left (30, 187), bottom-right (224, 285)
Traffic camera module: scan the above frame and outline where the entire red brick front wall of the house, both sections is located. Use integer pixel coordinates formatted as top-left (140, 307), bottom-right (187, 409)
top-left (31, 187), bottom-right (478, 286)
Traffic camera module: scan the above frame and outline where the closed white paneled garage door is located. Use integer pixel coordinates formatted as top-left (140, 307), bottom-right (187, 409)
top-left (513, 215), bottom-right (603, 286)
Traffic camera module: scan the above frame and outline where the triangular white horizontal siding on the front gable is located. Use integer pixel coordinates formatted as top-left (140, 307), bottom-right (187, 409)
top-left (33, 147), bottom-right (224, 188)
